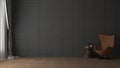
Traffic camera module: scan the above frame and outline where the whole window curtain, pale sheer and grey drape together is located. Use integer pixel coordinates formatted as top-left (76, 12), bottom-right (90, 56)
top-left (0, 0), bottom-right (14, 61)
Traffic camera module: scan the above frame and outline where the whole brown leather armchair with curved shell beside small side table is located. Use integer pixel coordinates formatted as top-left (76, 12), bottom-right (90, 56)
top-left (94, 34), bottom-right (115, 57)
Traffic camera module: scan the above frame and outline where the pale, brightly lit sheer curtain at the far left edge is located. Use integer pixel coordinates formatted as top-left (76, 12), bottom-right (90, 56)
top-left (0, 0), bottom-right (6, 61)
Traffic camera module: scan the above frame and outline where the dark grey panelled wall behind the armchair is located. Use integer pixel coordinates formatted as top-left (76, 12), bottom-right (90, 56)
top-left (12, 0), bottom-right (119, 56)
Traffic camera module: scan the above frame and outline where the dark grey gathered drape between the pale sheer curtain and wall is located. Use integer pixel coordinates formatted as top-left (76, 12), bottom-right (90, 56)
top-left (5, 0), bottom-right (14, 59)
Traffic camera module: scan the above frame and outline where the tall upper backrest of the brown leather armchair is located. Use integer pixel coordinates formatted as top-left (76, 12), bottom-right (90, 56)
top-left (98, 34), bottom-right (115, 50)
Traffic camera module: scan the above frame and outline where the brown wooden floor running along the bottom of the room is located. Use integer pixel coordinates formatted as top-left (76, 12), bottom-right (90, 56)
top-left (0, 57), bottom-right (120, 68)
